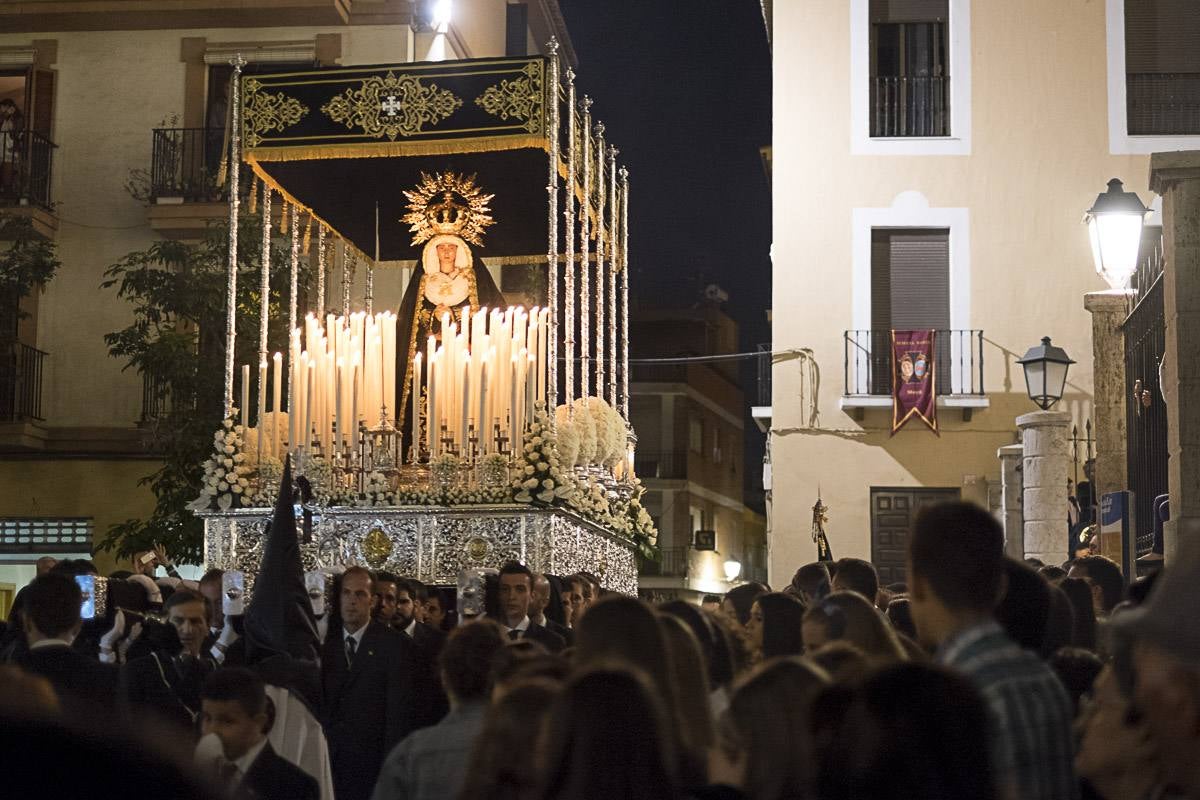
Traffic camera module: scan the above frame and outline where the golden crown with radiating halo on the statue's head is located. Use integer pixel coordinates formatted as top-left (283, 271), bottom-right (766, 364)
top-left (401, 173), bottom-right (496, 245)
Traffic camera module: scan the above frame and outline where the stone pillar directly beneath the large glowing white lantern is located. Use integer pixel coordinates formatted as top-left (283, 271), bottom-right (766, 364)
top-left (1084, 290), bottom-right (1132, 503)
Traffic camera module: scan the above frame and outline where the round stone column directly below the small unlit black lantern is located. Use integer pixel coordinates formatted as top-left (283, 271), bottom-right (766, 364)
top-left (1016, 411), bottom-right (1070, 565)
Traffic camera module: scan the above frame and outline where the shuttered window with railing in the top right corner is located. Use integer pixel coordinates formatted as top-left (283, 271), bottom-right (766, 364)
top-left (1124, 0), bottom-right (1200, 136)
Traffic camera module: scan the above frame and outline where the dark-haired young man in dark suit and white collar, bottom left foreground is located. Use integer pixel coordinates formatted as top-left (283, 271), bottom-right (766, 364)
top-left (200, 667), bottom-right (320, 800)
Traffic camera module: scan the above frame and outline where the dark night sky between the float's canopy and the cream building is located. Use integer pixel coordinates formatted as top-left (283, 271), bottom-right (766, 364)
top-left (559, 0), bottom-right (770, 501)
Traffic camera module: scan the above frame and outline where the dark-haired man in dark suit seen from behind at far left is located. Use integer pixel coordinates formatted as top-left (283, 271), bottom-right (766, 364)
top-left (20, 572), bottom-right (118, 717)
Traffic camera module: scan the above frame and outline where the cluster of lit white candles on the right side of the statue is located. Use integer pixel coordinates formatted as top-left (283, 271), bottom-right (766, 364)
top-left (409, 306), bottom-right (550, 455)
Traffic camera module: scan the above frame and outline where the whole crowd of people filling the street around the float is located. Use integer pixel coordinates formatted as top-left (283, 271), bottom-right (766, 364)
top-left (0, 503), bottom-right (1200, 800)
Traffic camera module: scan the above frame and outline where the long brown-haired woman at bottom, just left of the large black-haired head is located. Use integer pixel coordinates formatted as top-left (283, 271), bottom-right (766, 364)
top-left (709, 657), bottom-right (829, 800)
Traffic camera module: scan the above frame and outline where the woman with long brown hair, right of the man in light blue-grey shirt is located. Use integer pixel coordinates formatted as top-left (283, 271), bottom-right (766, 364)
top-left (458, 679), bottom-right (560, 800)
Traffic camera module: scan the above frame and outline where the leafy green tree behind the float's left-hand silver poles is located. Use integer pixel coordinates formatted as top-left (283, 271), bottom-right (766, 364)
top-left (100, 215), bottom-right (307, 563)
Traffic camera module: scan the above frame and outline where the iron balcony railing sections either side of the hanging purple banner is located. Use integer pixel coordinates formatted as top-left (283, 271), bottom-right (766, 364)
top-left (841, 330), bottom-right (989, 420)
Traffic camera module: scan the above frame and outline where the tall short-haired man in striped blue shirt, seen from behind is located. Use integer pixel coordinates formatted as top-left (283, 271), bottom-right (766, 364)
top-left (908, 503), bottom-right (1079, 800)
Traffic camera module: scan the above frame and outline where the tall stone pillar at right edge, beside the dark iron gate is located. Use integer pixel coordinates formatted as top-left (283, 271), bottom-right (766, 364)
top-left (1135, 150), bottom-right (1200, 564)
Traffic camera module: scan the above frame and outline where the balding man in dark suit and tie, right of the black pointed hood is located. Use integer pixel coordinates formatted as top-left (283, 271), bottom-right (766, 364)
top-left (322, 566), bottom-right (416, 800)
